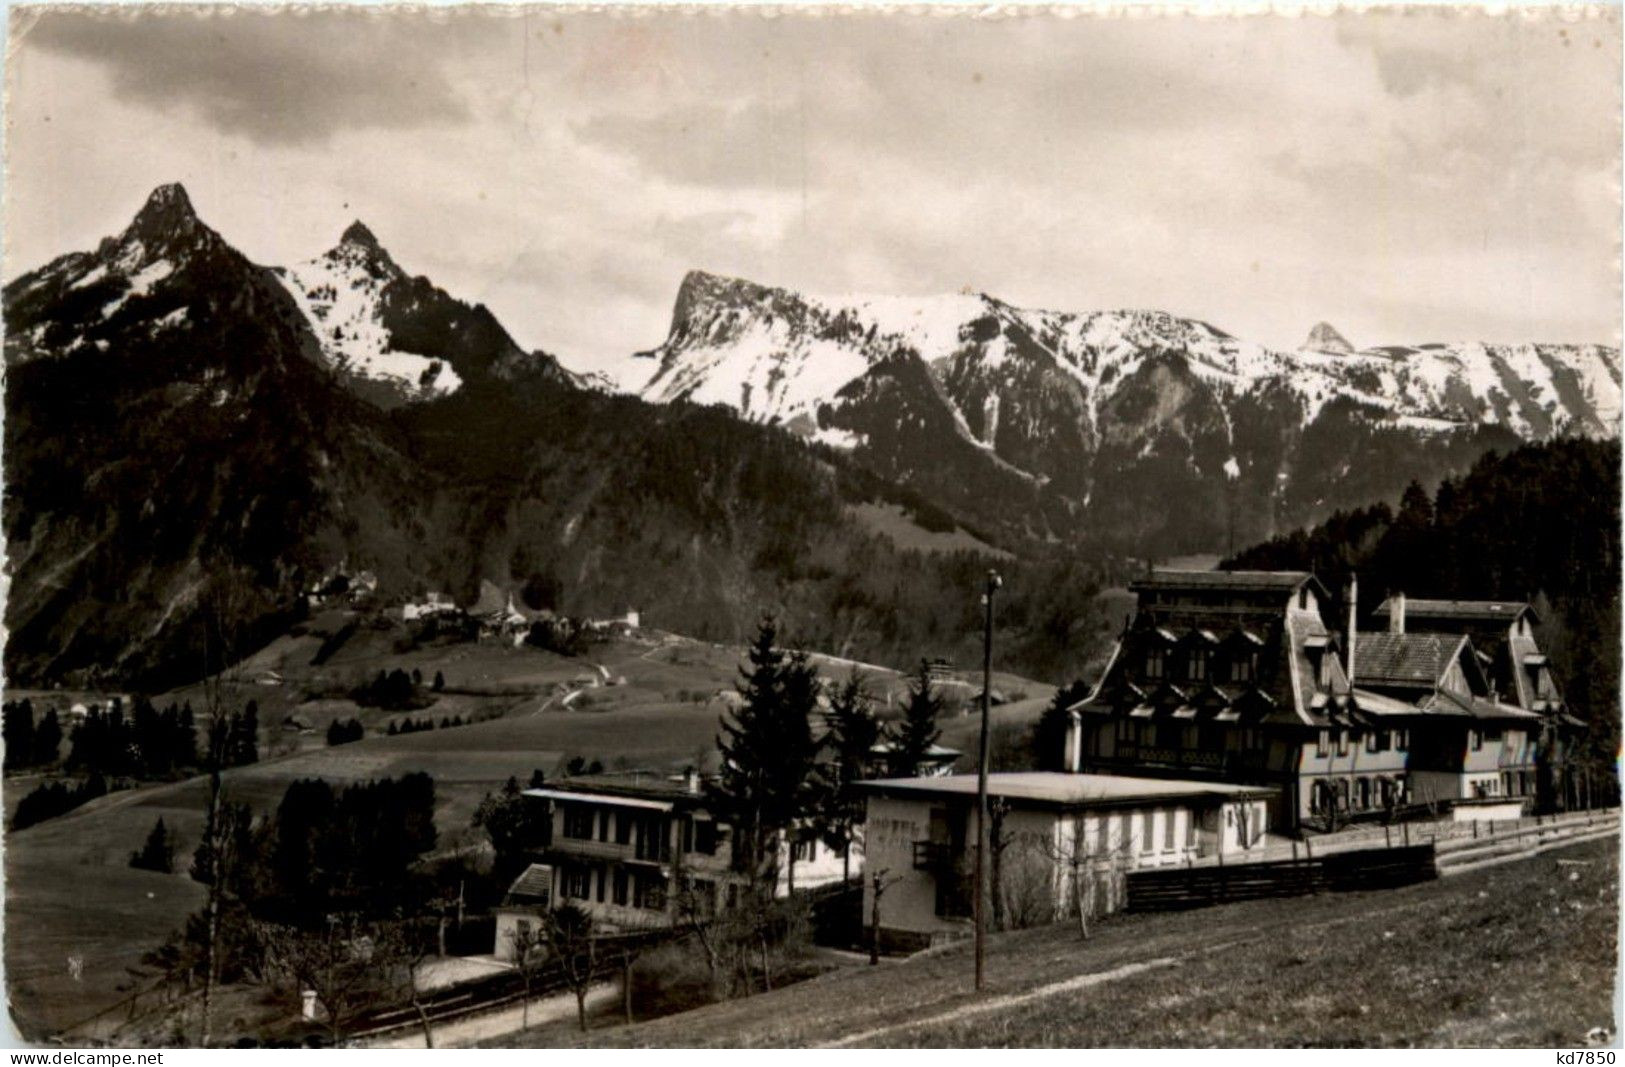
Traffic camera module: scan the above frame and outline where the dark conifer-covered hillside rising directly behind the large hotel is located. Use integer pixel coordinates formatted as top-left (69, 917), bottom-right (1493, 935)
top-left (1224, 438), bottom-right (1620, 770)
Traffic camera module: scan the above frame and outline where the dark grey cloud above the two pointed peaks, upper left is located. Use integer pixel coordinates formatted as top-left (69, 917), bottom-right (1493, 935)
top-left (26, 5), bottom-right (468, 145)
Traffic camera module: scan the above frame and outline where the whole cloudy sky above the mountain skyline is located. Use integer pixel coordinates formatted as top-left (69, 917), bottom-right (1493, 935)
top-left (5, 10), bottom-right (1620, 375)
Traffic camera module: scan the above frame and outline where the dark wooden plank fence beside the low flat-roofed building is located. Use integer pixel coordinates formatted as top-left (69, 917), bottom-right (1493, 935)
top-left (1126, 843), bottom-right (1438, 911)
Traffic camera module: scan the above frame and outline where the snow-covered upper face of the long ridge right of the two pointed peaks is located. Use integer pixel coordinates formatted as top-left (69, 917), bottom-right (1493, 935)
top-left (640, 276), bottom-right (1622, 437)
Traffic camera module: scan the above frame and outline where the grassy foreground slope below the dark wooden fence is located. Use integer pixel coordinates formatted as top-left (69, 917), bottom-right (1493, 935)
top-left (528, 841), bottom-right (1619, 1048)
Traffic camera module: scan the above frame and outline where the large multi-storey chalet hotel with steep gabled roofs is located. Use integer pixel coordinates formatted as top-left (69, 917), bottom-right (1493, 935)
top-left (1066, 572), bottom-right (1581, 832)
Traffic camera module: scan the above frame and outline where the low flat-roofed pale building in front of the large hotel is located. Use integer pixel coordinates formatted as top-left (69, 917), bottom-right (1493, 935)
top-left (860, 769), bottom-right (1274, 947)
